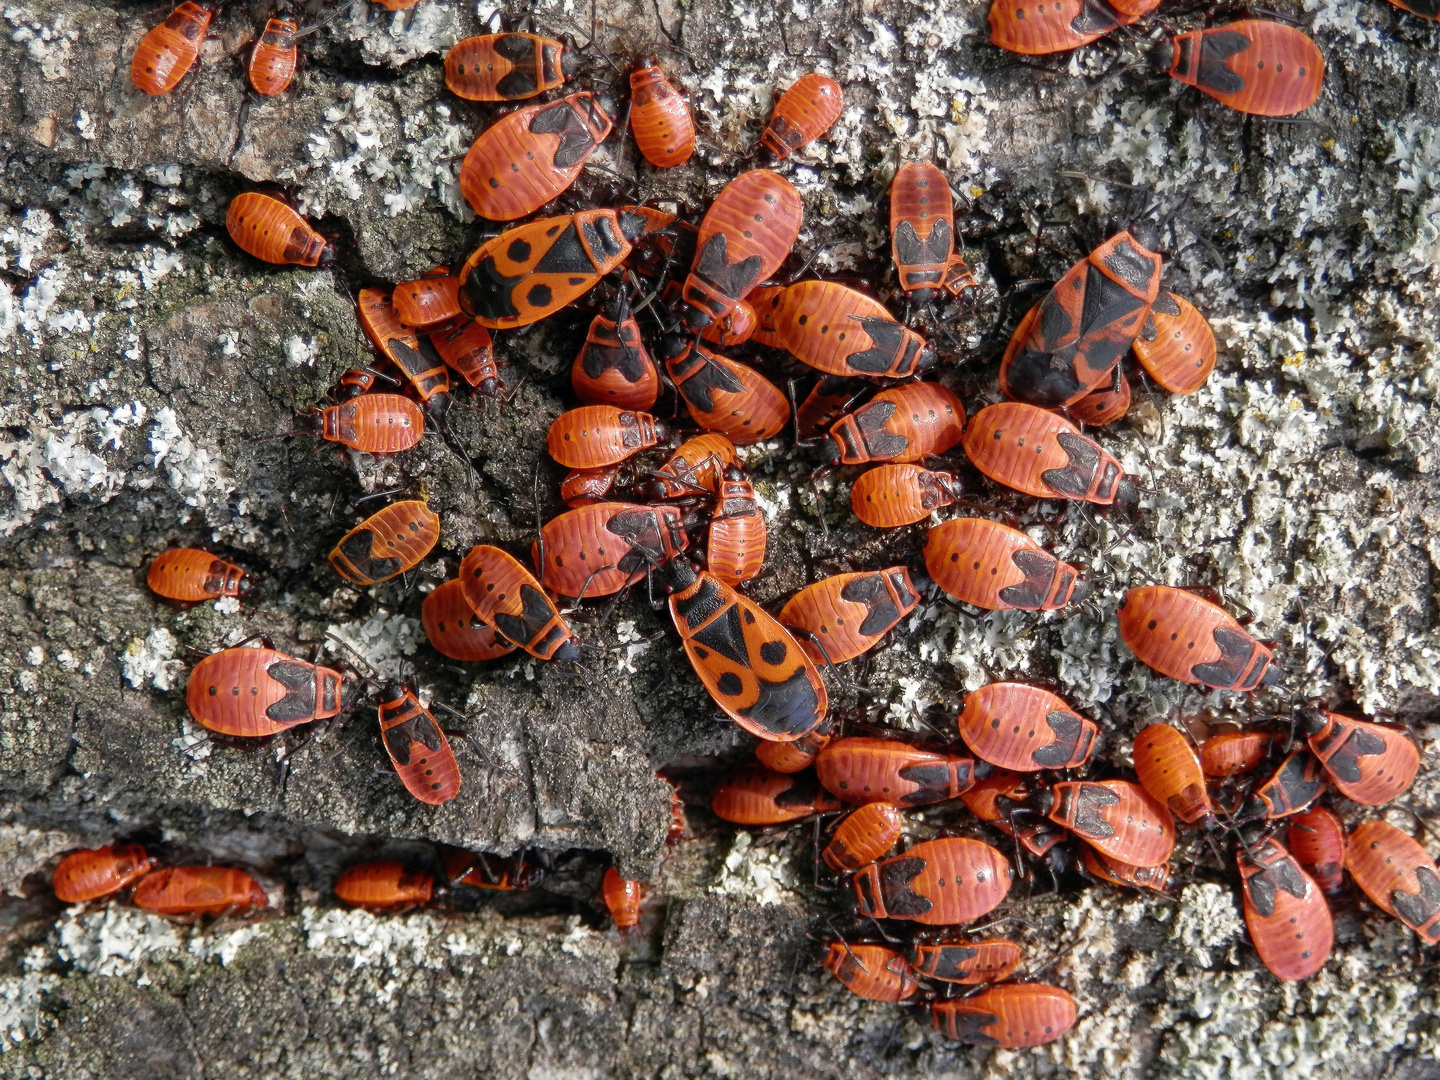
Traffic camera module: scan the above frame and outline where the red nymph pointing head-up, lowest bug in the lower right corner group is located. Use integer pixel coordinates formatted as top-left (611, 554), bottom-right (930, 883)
top-left (1236, 837), bottom-right (1335, 982)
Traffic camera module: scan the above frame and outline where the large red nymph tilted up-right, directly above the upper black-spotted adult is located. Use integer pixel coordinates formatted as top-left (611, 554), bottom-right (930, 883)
top-left (459, 91), bottom-right (612, 222)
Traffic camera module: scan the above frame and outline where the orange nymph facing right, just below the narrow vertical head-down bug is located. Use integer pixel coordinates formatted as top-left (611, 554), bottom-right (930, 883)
top-left (770, 281), bottom-right (935, 379)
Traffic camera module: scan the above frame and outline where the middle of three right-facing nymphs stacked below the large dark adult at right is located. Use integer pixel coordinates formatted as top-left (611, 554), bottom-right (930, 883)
top-left (924, 517), bottom-right (1090, 611)
